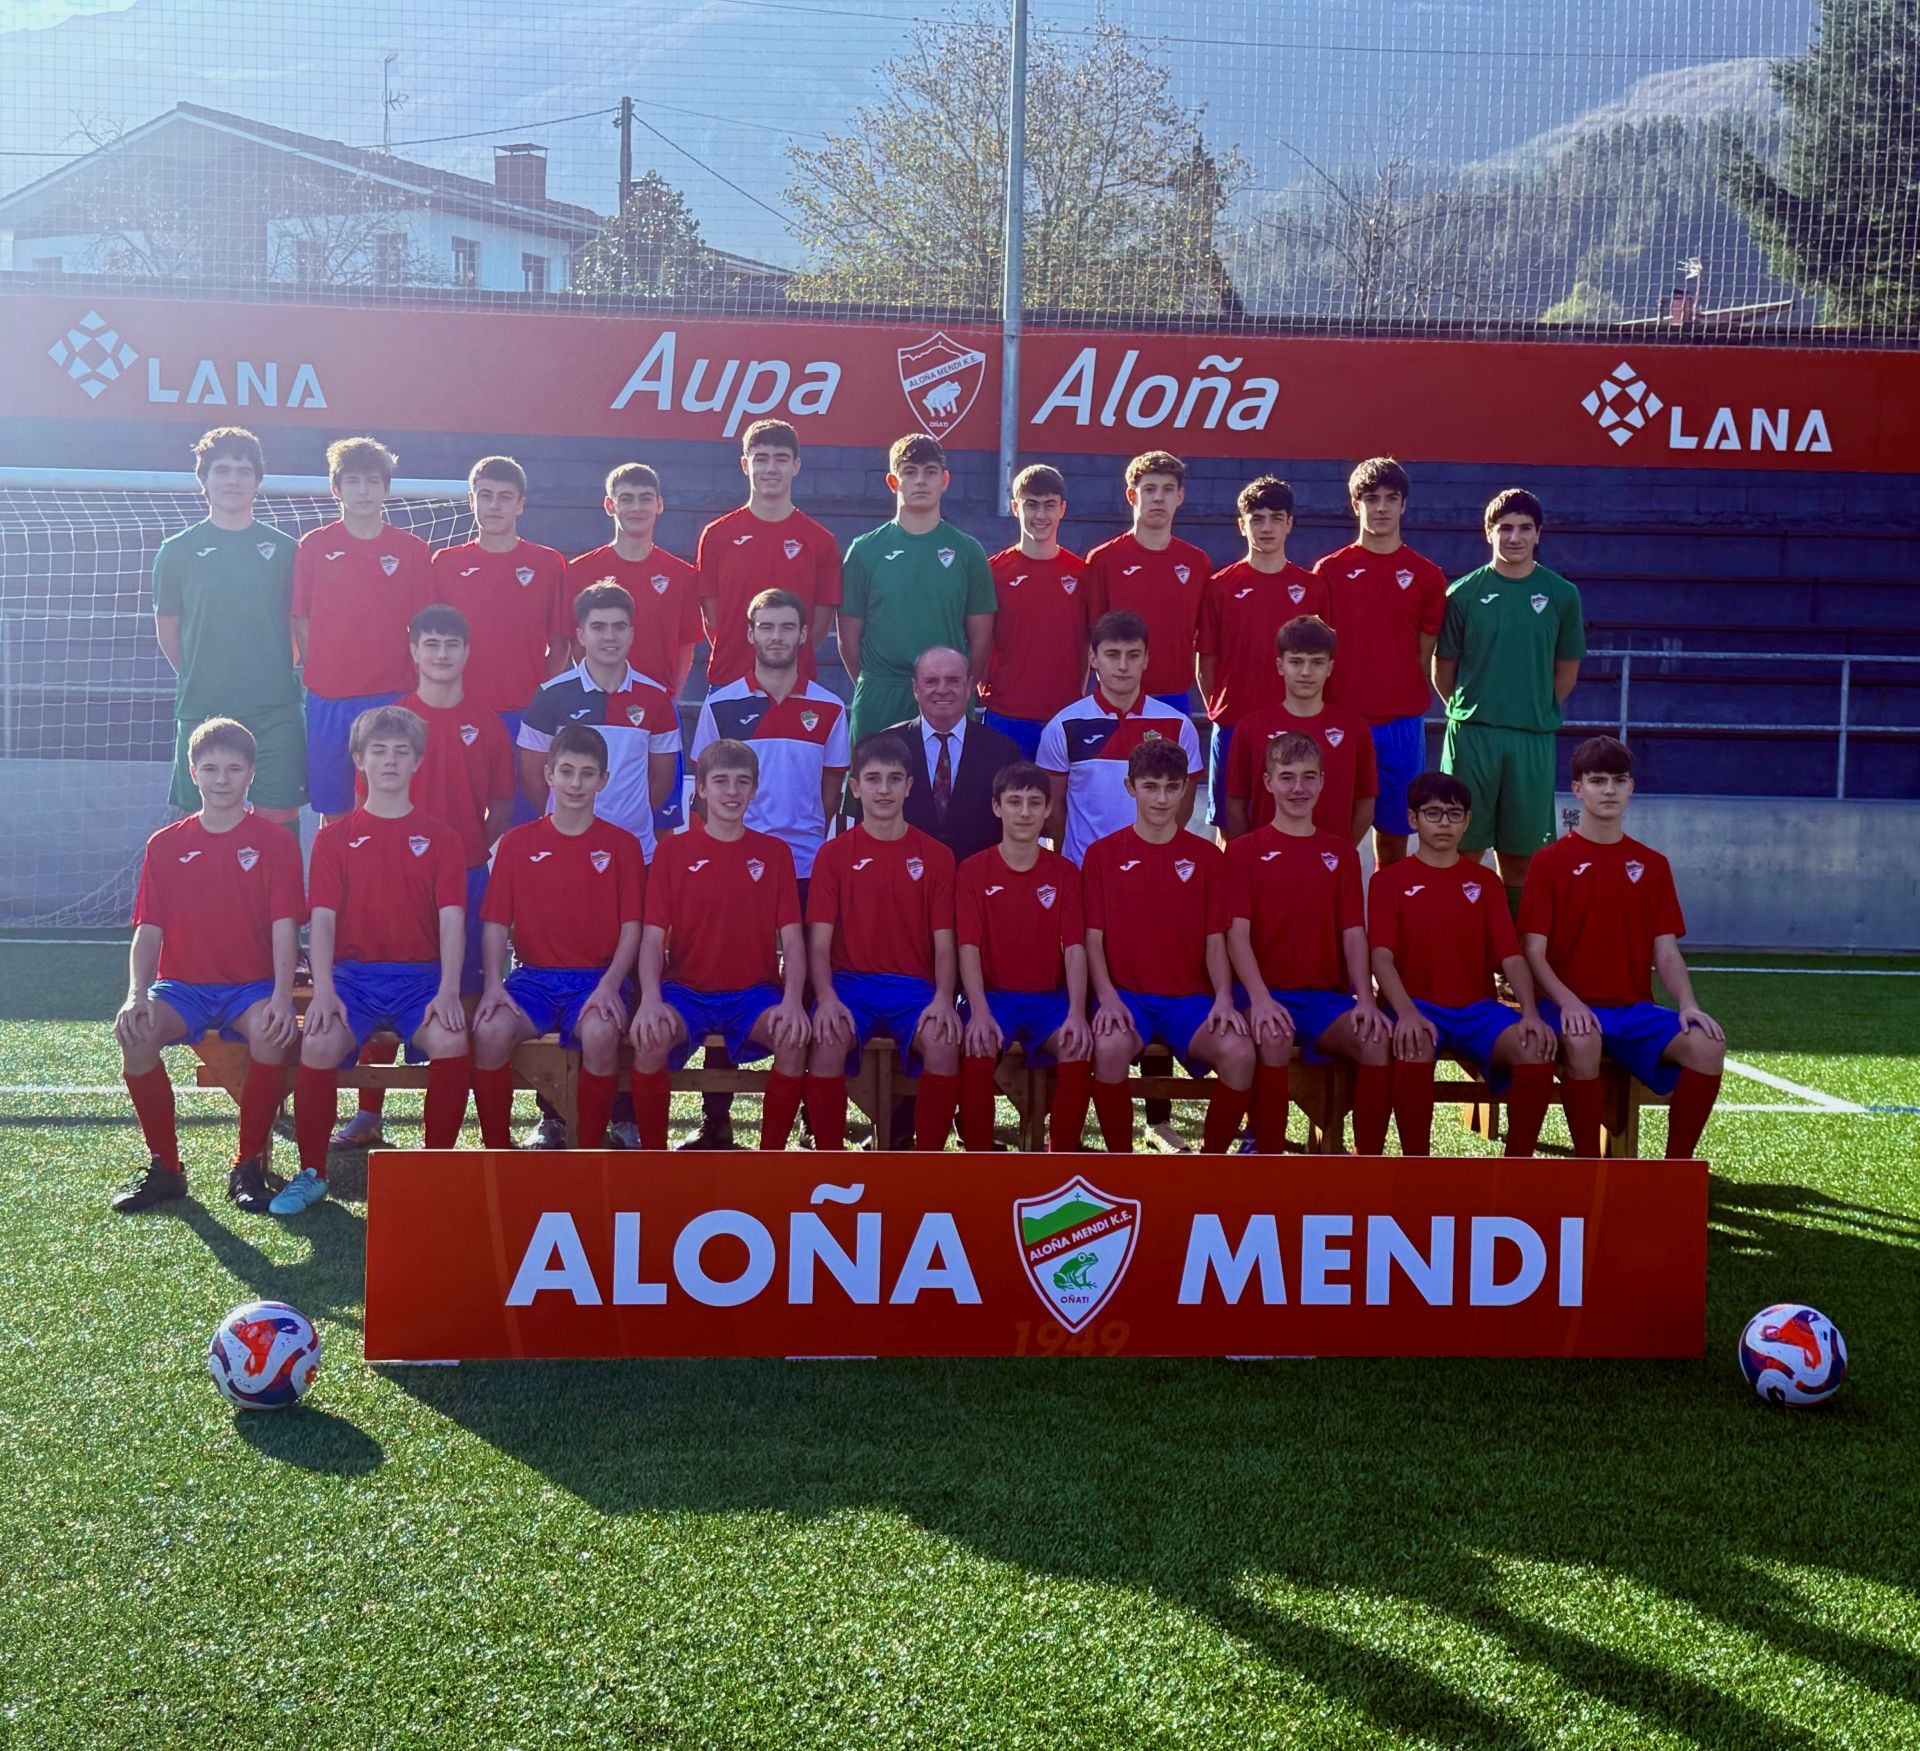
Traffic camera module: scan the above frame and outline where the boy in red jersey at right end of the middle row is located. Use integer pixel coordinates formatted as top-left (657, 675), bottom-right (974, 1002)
top-left (1227, 614), bottom-right (1380, 845)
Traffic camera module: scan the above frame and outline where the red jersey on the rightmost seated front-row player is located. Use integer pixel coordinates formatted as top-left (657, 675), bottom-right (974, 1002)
top-left (1521, 833), bottom-right (1686, 1008)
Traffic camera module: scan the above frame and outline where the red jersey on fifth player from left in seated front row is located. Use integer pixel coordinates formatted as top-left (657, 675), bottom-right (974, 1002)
top-left (806, 828), bottom-right (954, 981)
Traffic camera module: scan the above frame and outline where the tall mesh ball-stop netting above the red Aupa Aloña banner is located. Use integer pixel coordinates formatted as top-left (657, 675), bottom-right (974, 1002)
top-left (0, 0), bottom-right (1920, 344)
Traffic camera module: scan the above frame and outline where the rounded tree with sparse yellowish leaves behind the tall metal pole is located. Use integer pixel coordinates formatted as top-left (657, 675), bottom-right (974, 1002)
top-left (787, 6), bottom-right (1242, 315)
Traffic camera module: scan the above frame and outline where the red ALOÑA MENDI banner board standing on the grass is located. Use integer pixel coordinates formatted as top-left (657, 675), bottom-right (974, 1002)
top-left (365, 1150), bottom-right (1707, 1361)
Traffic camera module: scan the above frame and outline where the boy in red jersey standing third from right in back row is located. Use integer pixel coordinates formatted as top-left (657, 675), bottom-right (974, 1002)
top-left (1198, 474), bottom-right (1327, 829)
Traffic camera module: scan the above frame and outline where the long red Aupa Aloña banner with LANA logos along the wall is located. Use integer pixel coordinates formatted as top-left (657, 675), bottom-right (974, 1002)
top-left (0, 290), bottom-right (1920, 472)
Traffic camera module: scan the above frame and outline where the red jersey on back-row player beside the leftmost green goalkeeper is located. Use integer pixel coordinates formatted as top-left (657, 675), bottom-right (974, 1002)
top-left (294, 522), bottom-right (434, 699)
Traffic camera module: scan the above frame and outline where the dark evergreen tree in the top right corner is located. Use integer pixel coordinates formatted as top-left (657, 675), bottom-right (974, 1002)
top-left (1722, 0), bottom-right (1920, 326)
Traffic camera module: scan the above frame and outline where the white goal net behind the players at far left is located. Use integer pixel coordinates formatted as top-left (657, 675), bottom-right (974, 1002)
top-left (0, 468), bottom-right (468, 927)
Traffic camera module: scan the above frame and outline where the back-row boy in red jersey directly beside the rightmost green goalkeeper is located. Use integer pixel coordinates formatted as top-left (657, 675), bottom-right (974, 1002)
top-left (1313, 457), bottom-right (1446, 868)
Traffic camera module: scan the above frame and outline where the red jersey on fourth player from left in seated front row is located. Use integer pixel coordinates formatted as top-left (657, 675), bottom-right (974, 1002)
top-left (647, 816), bottom-right (801, 991)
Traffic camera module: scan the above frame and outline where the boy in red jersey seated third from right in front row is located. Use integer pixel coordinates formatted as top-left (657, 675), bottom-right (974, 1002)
top-left (1227, 732), bottom-right (1392, 1156)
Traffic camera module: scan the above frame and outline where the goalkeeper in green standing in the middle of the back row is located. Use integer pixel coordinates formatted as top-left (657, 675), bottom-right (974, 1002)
top-left (839, 432), bottom-right (996, 741)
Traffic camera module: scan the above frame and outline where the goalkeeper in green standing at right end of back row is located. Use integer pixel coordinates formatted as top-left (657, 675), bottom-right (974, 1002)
top-left (1434, 488), bottom-right (1586, 912)
